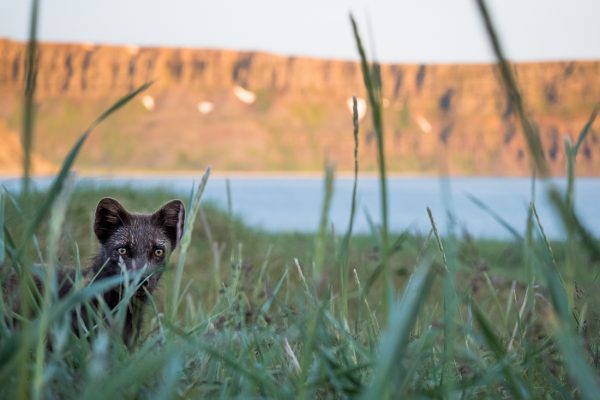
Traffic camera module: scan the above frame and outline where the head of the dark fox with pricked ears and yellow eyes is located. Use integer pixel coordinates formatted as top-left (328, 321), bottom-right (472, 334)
top-left (94, 197), bottom-right (185, 290)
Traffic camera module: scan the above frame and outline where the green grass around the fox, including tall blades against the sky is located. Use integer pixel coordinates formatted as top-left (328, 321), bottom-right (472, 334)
top-left (0, 1), bottom-right (600, 399)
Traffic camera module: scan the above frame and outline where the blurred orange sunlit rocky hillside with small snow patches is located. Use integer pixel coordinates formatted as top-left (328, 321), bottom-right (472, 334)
top-left (0, 40), bottom-right (600, 175)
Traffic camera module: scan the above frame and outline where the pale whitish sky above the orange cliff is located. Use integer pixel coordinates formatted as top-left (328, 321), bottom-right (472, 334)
top-left (0, 0), bottom-right (600, 62)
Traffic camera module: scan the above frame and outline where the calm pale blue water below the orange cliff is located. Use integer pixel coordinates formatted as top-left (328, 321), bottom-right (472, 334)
top-left (0, 176), bottom-right (600, 239)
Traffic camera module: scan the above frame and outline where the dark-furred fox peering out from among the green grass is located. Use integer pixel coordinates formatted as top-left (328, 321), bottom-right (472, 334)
top-left (4, 198), bottom-right (185, 345)
